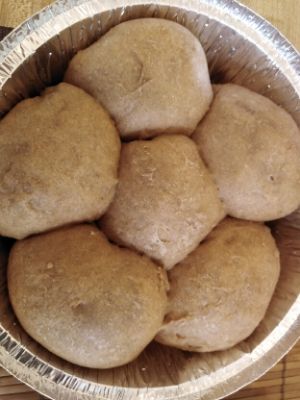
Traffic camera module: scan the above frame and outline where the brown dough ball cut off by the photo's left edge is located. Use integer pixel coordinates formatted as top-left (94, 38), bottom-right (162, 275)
top-left (0, 83), bottom-right (120, 239)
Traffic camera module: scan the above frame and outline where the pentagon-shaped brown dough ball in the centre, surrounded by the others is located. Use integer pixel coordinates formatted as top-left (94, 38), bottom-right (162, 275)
top-left (101, 135), bottom-right (225, 269)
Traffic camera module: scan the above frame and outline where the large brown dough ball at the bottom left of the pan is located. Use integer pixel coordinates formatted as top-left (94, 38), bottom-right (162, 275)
top-left (8, 225), bottom-right (167, 368)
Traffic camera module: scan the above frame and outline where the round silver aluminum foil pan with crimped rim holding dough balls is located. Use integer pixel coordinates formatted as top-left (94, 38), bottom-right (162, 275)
top-left (0, 0), bottom-right (300, 400)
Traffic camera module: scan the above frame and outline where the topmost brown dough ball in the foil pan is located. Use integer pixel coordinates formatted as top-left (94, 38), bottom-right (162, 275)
top-left (65, 18), bottom-right (212, 139)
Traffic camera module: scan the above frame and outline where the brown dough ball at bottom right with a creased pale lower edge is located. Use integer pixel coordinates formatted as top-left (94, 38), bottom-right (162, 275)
top-left (156, 218), bottom-right (280, 352)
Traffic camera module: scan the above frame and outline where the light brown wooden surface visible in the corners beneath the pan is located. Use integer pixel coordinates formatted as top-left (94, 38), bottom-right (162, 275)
top-left (0, 0), bottom-right (300, 400)
